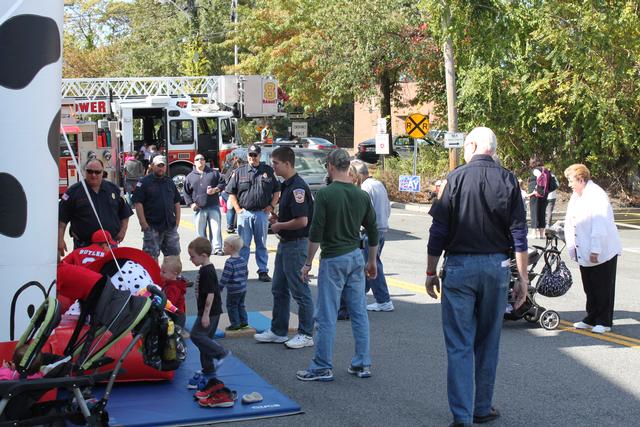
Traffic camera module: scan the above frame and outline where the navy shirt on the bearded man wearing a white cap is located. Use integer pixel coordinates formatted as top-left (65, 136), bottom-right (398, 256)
top-left (132, 173), bottom-right (180, 231)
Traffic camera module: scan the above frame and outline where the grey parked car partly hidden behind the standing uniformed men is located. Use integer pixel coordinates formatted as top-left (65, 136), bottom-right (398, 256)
top-left (225, 144), bottom-right (327, 194)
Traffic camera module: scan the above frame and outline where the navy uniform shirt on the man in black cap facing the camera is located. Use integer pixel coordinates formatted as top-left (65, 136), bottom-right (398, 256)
top-left (226, 162), bottom-right (280, 211)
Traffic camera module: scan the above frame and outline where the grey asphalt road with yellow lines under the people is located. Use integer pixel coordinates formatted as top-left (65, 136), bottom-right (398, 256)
top-left (115, 208), bottom-right (640, 426)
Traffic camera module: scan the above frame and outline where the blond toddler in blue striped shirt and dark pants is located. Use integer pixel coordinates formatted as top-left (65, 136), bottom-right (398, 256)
top-left (220, 235), bottom-right (249, 331)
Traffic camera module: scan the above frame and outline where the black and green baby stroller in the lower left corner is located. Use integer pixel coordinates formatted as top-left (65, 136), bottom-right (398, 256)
top-left (0, 270), bottom-right (177, 427)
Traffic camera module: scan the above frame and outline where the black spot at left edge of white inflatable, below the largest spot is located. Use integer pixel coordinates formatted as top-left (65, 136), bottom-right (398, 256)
top-left (0, 172), bottom-right (27, 238)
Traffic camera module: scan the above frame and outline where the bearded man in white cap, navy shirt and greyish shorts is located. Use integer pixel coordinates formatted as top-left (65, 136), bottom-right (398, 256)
top-left (132, 156), bottom-right (180, 260)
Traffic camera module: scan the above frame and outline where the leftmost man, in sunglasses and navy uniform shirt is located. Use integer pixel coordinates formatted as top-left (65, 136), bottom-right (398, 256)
top-left (58, 159), bottom-right (133, 256)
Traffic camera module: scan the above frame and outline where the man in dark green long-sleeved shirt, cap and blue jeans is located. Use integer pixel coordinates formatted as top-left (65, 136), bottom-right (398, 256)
top-left (296, 149), bottom-right (378, 381)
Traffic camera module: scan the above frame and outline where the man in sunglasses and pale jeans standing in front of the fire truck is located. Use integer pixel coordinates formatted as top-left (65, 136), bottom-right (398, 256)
top-left (184, 154), bottom-right (225, 255)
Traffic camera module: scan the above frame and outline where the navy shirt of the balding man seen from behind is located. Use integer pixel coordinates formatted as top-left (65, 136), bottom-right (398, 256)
top-left (429, 155), bottom-right (527, 255)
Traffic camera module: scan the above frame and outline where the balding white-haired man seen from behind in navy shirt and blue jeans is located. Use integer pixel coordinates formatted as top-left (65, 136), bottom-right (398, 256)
top-left (425, 127), bottom-right (529, 427)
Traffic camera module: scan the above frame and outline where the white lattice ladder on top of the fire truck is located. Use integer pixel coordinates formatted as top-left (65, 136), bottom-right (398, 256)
top-left (62, 76), bottom-right (225, 102)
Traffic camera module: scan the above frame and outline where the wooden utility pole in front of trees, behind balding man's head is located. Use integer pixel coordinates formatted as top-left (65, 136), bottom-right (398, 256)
top-left (442, 0), bottom-right (458, 171)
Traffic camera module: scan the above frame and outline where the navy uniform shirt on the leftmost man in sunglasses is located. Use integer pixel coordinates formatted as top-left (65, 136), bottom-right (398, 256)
top-left (58, 180), bottom-right (133, 245)
